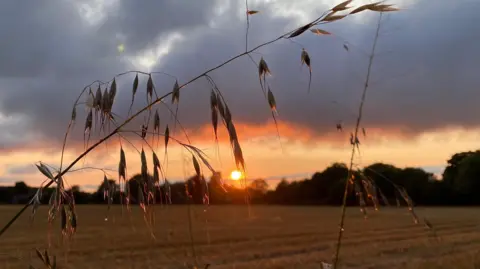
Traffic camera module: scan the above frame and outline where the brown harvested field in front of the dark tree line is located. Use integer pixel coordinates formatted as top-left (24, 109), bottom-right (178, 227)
top-left (0, 205), bottom-right (480, 269)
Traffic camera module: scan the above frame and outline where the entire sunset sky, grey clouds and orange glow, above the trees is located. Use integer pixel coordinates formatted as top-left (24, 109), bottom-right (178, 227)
top-left (0, 0), bottom-right (480, 190)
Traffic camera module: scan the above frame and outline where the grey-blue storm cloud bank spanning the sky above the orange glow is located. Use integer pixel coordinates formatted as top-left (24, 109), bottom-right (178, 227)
top-left (0, 0), bottom-right (480, 149)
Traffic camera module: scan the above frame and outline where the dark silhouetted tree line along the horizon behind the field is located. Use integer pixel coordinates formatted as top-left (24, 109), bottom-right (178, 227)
top-left (0, 150), bottom-right (480, 205)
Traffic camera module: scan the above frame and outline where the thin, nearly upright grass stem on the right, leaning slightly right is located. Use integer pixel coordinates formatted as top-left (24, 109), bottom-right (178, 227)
top-left (333, 13), bottom-right (382, 269)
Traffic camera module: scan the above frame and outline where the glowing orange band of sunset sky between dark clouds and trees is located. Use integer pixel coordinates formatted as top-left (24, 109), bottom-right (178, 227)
top-left (0, 120), bottom-right (480, 192)
